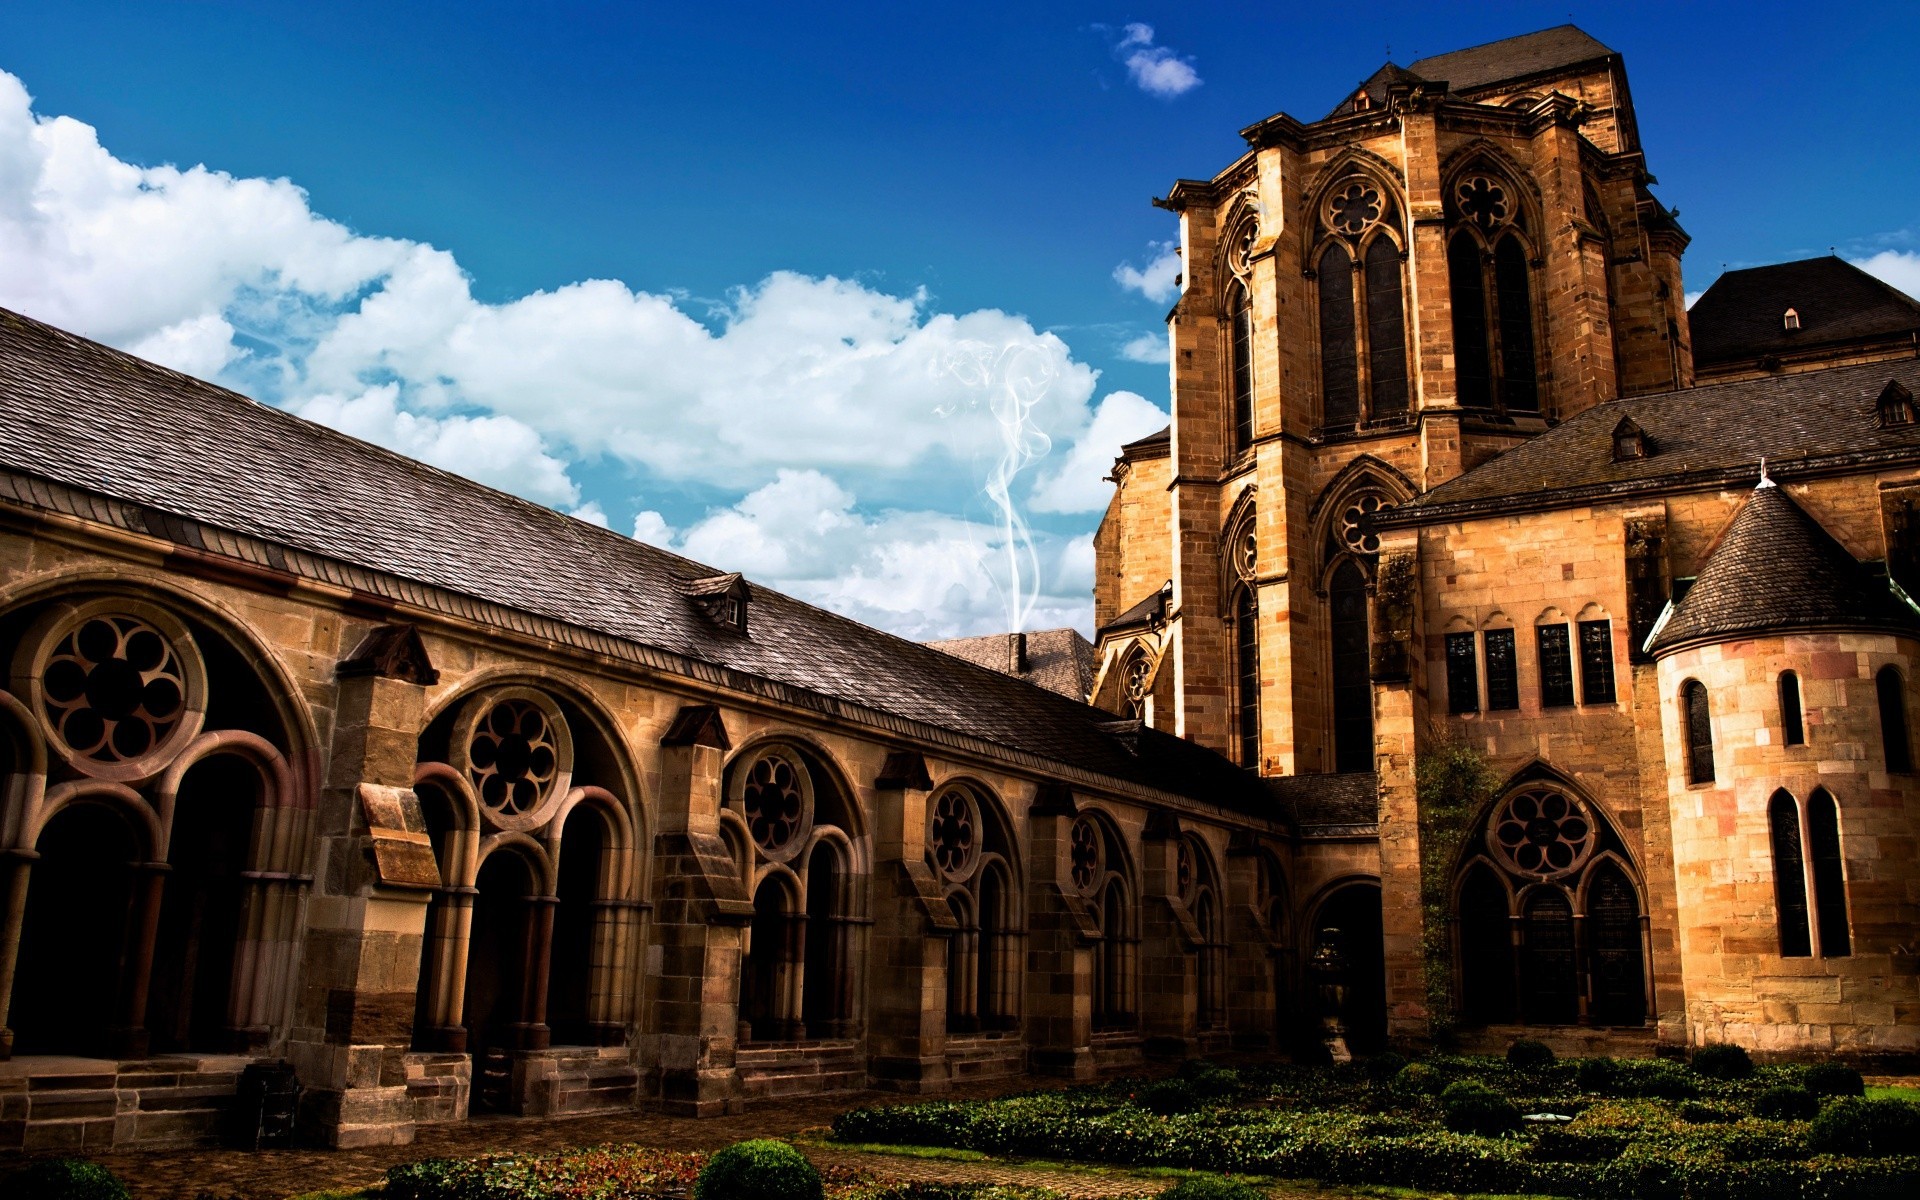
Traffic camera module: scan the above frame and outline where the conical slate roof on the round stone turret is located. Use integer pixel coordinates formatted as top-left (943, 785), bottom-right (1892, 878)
top-left (1649, 480), bottom-right (1920, 655)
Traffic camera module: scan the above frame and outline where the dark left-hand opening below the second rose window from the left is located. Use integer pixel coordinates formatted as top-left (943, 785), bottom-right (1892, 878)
top-left (461, 851), bottom-right (540, 1112)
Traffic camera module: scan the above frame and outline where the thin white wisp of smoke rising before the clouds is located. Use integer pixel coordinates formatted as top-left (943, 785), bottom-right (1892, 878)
top-left (943, 342), bottom-right (1058, 632)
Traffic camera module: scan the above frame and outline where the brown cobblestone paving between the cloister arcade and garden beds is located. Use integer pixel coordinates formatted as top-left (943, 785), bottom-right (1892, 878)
top-left (0, 1079), bottom-right (1340, 1200)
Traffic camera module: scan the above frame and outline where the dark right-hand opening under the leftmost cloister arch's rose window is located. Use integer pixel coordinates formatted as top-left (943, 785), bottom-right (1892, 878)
top-left (146, 755), bottom-right (261, 1054)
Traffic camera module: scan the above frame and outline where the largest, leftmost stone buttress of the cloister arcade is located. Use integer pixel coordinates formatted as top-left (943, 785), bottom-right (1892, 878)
top-left (288, 626), bottom-right (440, 1146)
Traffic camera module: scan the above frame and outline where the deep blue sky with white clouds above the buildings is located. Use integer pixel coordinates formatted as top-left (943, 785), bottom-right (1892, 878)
top-left (0, 0), bottom-right (1920, 636)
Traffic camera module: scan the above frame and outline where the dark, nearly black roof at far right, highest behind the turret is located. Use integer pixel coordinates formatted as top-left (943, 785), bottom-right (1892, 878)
top-left (1688, 255), bottom-right (1920, 367)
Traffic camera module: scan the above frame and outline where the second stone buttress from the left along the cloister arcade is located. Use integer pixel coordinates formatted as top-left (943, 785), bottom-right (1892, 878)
top-left (647, 705), bottom-right (753, 1117)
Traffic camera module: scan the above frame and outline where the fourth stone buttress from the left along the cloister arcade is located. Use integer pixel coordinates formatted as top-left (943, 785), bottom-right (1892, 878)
top-left (1027, 783), bottom-right (1100, 1079)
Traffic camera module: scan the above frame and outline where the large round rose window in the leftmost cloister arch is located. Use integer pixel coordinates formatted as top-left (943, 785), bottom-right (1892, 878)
top-left (40, 614), bottom-right (186, 764)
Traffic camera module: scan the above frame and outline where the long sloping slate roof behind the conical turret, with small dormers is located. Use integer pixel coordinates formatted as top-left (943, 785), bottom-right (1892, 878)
top-left (1375, 359), bottom-right (1920, 528)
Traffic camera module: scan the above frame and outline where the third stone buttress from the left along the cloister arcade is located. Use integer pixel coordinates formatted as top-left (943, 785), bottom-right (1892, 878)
top-left (868, 751), bottom-right (958, 1092)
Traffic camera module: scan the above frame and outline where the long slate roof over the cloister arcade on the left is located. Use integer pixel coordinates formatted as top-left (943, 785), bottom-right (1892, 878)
top-left (0, 309), bottom-right (1271, 816)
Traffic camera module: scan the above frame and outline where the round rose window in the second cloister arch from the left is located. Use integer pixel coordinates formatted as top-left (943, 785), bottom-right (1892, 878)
top-left (453, 687), bottom-right (574, 831)
